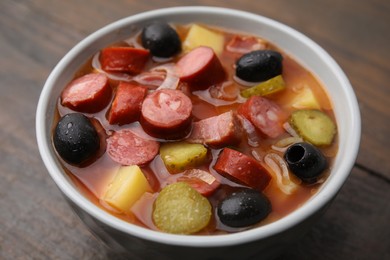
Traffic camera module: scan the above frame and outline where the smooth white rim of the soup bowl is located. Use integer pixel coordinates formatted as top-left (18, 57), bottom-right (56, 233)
top-left (36, 6), bottom-right (361, 247)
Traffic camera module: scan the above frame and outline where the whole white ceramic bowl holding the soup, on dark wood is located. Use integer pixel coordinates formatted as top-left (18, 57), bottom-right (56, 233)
top-left (36, 7), bottom-right (361, 260)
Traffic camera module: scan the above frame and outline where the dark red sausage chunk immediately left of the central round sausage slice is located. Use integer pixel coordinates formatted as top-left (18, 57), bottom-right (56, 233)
top-left (108, 82), bottom-right (148, 125)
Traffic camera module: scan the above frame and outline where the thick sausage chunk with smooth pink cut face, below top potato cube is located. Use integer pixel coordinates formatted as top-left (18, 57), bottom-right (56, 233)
top-left (176, 46), bottom-right (226, 90)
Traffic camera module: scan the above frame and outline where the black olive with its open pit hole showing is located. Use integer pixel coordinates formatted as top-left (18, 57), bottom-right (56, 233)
top-left (284, 142), bottom-right (328, 183)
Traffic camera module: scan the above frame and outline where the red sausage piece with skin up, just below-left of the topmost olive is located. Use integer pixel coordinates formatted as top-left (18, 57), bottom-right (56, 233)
top-left (100, 47), bottom-right (149, 74)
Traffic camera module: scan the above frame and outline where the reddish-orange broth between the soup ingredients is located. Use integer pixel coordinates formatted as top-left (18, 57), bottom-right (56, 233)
top-left (54, 25), bottom-right (338, 235)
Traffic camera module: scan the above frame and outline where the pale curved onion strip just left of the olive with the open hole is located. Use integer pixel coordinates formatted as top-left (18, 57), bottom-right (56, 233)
top-left (264, 153), bottom-right (299, 195)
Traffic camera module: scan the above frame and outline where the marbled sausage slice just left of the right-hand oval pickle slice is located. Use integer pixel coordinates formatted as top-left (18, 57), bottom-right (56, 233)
top-left (237, 96), bottom-right (286, 138)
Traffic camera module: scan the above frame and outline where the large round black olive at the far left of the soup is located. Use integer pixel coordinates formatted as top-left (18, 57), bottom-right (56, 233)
top-left (53, 113), bottom-right (100, 164)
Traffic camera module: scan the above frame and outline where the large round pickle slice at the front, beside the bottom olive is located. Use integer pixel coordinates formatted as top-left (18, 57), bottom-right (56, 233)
top-left (153, 182), bottom-right (211, 234)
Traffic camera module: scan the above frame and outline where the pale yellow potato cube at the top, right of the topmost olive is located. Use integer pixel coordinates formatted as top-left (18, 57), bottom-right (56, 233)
top-left (183, 24), bottom-right (224, 55)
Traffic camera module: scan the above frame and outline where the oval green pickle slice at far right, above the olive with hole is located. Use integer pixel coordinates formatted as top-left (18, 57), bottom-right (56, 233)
top-left (290, 110), bottom-right (336, 146)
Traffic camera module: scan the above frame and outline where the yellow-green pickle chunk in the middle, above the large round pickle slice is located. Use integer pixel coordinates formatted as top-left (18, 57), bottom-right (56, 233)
top-left (160, 142), bottom-right (207, 173)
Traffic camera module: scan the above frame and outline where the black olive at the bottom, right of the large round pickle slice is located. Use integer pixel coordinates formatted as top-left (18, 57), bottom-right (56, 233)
top-left (217, 188), bottom-right (271, 228)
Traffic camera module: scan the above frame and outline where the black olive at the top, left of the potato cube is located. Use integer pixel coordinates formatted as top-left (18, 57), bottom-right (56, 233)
top-left (141, 22), bottom-right (181, 58)
